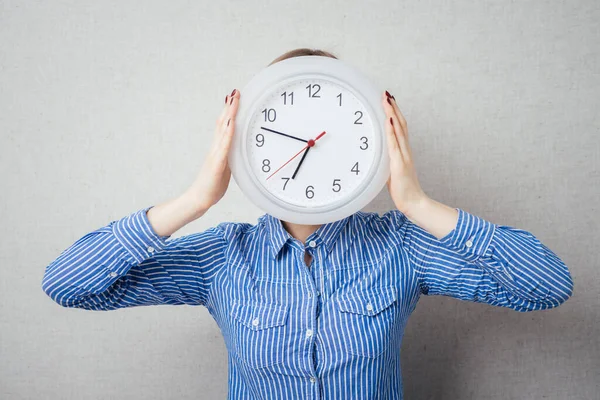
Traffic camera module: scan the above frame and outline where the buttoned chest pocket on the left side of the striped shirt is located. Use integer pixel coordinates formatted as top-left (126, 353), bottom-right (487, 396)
top-left (230, 300), bottom-right (289, 368)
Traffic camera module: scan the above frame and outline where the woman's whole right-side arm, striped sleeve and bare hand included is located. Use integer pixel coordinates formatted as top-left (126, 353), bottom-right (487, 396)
top-left (382, 92), bottom-right (573, 311)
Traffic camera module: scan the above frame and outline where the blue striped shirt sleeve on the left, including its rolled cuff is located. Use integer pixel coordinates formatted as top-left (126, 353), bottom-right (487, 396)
top-left (42, 206), bottom-right (225, 310)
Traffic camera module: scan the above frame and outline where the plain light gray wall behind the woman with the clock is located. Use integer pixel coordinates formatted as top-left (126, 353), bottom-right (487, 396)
top-left (0, 0), bottom-right (600, 400)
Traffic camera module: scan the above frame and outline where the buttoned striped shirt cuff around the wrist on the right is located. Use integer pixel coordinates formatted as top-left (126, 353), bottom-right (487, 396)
top-left (439, 208), bottom-right (496, 262)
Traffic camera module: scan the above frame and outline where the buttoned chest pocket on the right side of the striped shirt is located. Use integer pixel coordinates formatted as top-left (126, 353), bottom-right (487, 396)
top-left (336, 286), bottom-right (397, 358)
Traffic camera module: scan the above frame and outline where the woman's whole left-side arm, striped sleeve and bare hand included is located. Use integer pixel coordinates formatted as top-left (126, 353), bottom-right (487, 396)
top-left (42, 92), bottom-right (239, 310)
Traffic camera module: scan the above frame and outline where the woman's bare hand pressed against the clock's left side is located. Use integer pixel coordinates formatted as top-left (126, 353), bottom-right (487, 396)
top-left (186, 89), bottom-right (240, 216)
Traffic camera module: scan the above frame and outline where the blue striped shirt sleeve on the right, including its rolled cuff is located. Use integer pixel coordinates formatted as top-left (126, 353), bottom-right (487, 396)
top-left (404, 208), bottom-right (573, 312)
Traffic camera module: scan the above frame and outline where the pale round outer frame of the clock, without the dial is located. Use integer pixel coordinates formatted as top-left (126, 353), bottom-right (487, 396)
top-left (229, 56), bottom-right (389, 224)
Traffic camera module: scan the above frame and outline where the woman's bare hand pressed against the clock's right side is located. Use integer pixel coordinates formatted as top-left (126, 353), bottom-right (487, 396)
top-left (382, 91), bottom-right (428, 216)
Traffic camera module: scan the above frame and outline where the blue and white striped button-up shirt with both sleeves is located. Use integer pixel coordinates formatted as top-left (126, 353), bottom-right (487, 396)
top-left (42, 207), bottom-right (573, 400)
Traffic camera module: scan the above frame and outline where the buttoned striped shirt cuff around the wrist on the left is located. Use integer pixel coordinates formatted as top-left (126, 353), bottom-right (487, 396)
top-left (112, 206), bottom-right (170, 264)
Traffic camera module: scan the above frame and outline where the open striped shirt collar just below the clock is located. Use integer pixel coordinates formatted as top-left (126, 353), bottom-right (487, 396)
top-left (261, 214), bottom-right (352, 258)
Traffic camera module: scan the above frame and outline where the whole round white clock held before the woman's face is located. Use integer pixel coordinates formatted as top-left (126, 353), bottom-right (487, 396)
top-left (229, 56), bottom-right (389, 224)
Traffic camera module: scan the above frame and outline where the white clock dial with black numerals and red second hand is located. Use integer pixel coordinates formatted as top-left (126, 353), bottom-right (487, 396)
top-left (245, 77), bottom-right (379, 208)
